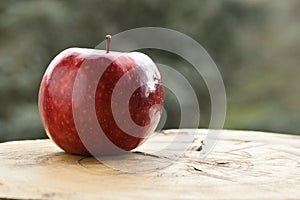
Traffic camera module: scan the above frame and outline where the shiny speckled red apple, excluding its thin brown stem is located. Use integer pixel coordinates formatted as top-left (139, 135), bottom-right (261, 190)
top-left (38, 48), bottom-right (164, 155)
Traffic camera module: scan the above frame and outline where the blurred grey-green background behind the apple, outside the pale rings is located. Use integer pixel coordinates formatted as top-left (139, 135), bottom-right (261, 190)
top-left (0, 0), bottom-right (300, 141)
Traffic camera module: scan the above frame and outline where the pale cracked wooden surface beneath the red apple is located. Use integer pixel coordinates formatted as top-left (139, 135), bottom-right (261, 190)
top-left (0, 129), bottom-right (300, 200)
